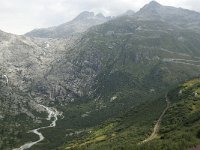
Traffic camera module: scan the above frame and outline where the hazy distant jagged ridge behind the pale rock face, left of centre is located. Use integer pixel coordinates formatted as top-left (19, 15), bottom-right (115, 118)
top-left (26, 11), bottom-right (110, 38)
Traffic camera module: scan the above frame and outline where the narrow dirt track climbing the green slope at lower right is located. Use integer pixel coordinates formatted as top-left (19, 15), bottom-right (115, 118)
top-left (139, 94), bottom-right (171, 144)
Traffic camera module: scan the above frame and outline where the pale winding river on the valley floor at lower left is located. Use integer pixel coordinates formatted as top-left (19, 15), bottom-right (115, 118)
top-left (13, 104), bottom-right (59, 150)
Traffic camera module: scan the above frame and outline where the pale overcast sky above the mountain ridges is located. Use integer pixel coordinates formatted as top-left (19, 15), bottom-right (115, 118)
top-left (0, 0), bottom-right (200, 34)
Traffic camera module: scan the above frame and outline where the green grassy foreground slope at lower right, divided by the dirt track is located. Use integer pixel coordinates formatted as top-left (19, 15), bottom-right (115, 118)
top-left (60, 78), bottom-right (200, 150)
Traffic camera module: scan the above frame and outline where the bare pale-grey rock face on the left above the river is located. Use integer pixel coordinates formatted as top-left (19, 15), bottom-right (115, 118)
top-left (0, 28), bottom-right (101, 117)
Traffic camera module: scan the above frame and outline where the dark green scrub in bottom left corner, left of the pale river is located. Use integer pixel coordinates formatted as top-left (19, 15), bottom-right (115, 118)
top-left (0, 115), bottom-right (38, 150)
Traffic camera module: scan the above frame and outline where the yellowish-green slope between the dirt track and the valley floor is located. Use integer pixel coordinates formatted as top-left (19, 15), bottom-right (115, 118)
top-left (59, 95), bottom-right (165, 150)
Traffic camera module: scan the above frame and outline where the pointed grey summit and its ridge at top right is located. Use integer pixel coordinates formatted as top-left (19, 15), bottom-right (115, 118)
top-left (136, 1), bottom-right (200, 26)
